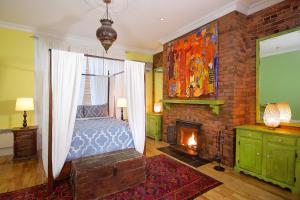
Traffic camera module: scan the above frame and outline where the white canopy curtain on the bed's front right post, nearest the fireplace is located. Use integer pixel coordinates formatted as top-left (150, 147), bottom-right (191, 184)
top-left (124, 61), bottom-right (145, 153)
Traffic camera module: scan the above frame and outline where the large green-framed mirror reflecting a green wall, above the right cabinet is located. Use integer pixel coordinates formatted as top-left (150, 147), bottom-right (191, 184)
top-left (256, 28), bottom-right (300, 125)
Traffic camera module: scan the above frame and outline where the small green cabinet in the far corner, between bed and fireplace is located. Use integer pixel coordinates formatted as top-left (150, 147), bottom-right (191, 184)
top-left (146, 113), bottom-right (162, 140)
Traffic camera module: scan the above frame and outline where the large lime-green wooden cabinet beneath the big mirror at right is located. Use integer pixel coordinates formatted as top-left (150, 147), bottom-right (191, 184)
top-left (235, 125), bottom-right (300, 195)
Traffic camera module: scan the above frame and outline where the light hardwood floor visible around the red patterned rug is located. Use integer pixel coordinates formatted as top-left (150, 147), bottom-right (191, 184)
top-left (0, 139), bottom-right (300, 200)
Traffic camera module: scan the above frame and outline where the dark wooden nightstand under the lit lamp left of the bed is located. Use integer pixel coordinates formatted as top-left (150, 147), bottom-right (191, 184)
top-left (12, 126), bottom-right (37, 160)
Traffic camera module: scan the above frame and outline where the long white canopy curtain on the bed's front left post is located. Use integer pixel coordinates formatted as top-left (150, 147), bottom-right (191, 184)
top-left (52, 50), bottom-right (86, 178)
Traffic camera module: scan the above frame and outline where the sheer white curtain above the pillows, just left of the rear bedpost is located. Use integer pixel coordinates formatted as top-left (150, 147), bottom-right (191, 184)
top-left (88, 58), bottom-right (108, 105)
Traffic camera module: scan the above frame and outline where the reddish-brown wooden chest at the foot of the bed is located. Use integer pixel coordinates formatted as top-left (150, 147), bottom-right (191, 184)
top-left (71, 149), bottom-right (146, 200)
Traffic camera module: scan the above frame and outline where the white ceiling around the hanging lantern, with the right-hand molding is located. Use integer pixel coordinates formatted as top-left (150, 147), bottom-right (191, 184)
top-left (0, 0), bottom-right (282, 52)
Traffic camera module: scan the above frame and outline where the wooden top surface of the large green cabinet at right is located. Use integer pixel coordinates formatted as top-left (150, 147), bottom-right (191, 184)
top-left (236, 125), bottom-right (300, 137)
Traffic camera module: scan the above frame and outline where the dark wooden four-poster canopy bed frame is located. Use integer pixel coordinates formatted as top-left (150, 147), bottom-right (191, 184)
top-left (48, 49), bottom-right (146, 193)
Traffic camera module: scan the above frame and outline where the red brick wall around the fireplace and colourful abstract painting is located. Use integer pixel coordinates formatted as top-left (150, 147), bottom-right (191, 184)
top-left (163, 0), bottom-right (300, 166)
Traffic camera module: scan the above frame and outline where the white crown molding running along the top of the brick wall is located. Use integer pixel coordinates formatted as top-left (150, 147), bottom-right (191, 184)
top-left (159, 0), bottom-right (284, 44)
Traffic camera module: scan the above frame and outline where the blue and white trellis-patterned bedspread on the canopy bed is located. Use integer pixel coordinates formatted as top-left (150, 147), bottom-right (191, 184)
top-left (67, 118), bottom-right (134, 160)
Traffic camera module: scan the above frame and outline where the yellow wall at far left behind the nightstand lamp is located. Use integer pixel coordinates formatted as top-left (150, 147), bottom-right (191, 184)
top-left (0, 28), bottom-right (34, 129)
